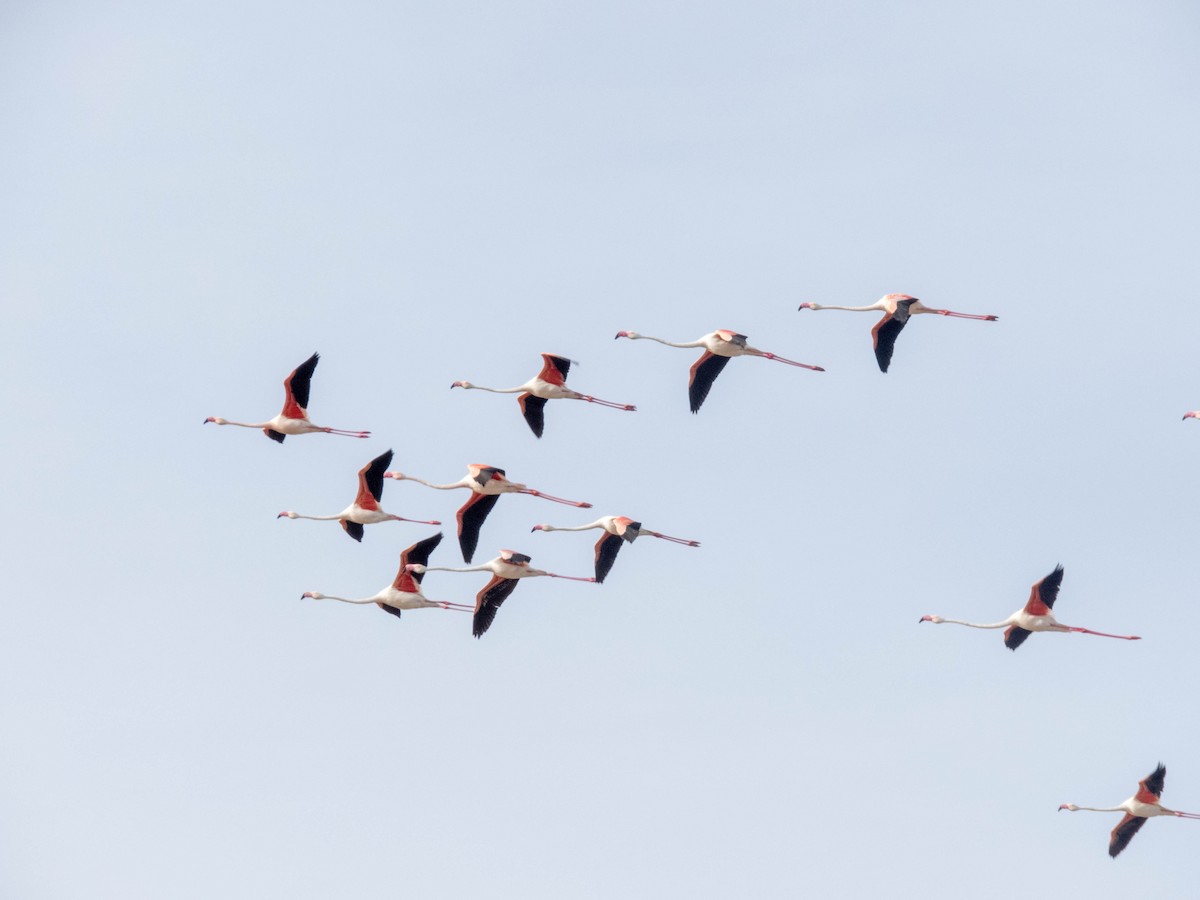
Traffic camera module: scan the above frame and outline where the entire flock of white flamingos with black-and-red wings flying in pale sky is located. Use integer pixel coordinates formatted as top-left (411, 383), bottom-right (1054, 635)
top-left (204, 294), bottom-right (1200, 857)
